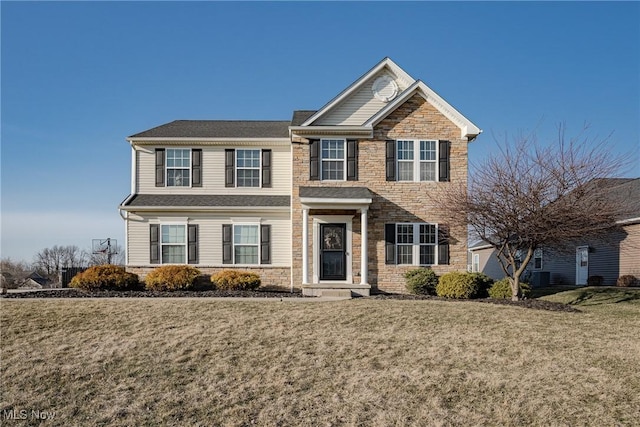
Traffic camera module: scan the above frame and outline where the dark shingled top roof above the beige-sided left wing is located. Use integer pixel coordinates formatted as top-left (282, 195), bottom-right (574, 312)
top-left (129, 120), bottom-right (291, 138)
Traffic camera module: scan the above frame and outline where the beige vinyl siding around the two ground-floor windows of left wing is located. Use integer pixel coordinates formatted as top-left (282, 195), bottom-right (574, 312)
top-left (127, 212), bottom-right (291, 267)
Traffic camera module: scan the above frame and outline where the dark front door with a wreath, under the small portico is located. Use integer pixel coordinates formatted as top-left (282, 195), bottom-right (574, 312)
top-left (320, 224), bottom-right (347, 280)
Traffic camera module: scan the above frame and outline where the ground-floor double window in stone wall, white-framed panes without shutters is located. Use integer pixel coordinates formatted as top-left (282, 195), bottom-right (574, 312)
top-left (396, 223), bottom-right (438, 265)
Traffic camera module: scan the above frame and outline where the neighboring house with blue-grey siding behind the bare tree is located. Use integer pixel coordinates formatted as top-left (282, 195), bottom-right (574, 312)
top-left (469, 178), bottom-right (640, 286)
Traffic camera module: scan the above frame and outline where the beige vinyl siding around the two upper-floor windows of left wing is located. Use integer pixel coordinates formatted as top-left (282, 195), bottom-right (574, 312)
top-left (137, 144), bottom-right (291, 195)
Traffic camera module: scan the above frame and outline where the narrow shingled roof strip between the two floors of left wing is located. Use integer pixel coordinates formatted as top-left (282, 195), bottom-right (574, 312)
top-left (124, 194), bottom-right (291, 208)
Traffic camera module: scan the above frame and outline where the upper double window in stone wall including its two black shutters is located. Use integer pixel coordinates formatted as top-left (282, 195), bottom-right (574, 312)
top-left (386, 139), bottom-right (450, 182)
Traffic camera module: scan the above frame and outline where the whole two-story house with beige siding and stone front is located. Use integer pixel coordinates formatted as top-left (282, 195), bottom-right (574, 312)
top-left (119, 58), bottom-right (481, 295)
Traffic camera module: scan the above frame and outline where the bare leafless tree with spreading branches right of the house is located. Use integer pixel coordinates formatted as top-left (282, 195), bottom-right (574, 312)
top-left (439, 125), bottom-right (627, 300)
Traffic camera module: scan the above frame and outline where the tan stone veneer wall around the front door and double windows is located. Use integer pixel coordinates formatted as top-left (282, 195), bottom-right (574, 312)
top-left (292, 95), bottom-right (468, 292)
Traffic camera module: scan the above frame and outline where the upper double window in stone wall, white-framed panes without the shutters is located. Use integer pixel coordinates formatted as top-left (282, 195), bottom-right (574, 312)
top-left (396, 139), bottom-right (438, 181)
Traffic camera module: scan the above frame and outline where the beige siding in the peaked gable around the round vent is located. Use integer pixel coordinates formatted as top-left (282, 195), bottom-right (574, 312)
top-left (313, 70), bottom-right (407, 126)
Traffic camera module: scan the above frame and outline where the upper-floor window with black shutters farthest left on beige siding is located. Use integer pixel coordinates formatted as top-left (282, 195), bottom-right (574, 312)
top-left (155, 148), bottom-right (202, 187)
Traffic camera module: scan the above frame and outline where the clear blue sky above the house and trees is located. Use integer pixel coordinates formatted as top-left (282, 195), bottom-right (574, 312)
top-left (0, 1), bottom-right (640, 261)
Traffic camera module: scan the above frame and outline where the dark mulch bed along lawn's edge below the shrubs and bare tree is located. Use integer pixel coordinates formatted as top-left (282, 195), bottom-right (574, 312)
top-left (2, 289), bottom-right (580, 313)
